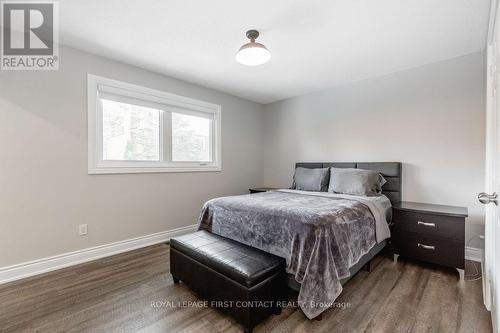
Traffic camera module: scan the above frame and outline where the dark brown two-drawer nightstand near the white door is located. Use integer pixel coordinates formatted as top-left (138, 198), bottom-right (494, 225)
top-left (391, 201), bottom-right (468, 279)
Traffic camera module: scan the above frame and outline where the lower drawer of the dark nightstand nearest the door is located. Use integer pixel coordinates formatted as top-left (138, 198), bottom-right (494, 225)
top-left (393, 232), bottom-right (465, 269)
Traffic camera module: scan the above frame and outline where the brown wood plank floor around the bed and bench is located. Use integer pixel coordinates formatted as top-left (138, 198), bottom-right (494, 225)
top-left (0, 245), bottom-right (491, 333)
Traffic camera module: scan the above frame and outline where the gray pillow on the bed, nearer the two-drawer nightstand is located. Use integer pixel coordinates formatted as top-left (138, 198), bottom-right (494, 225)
top-left (328, 168), bottom-right (386, 196)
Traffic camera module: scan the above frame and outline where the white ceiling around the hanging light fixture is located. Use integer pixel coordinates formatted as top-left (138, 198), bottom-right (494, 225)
top-left (60, 0), bottom-right (489, 103)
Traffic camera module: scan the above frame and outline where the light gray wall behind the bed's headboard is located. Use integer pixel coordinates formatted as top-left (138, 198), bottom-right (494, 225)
top-left (264, 53), bottom-right (486, 247)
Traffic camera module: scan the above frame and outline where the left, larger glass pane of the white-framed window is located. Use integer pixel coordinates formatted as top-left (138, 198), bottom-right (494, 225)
top-left (101, 99), bottom-right (160, 161)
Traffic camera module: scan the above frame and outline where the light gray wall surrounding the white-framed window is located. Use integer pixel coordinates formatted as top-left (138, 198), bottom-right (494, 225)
top-left (0, 48), bottom-right (263, 267)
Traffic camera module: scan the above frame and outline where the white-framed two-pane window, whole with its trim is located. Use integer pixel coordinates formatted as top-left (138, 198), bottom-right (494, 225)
top-left (88, 75), bottom-right (221, 174)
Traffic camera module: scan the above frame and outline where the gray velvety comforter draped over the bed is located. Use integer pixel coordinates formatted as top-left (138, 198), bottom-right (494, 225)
top-left (198, 190), bottom-right (389, 318)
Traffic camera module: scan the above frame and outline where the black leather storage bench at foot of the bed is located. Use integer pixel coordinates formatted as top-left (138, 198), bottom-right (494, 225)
top-left (170, 231), bottom-right (286, 332)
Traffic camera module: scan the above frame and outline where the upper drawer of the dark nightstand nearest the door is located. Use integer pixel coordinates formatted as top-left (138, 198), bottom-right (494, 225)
top-left (392, 210), bottom-right (465, 242)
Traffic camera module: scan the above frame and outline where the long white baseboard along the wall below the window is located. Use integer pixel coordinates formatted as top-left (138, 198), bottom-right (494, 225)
top-left (0, 225), bottom-right (196, 284)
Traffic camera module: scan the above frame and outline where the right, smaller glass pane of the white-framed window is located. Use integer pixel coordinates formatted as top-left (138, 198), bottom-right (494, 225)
top-left (172, 113), bottom-right (212, 162)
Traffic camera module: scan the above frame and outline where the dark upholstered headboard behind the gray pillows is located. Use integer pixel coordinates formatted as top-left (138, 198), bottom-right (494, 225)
top-left (295, 162), bottom-right (402, 204)
